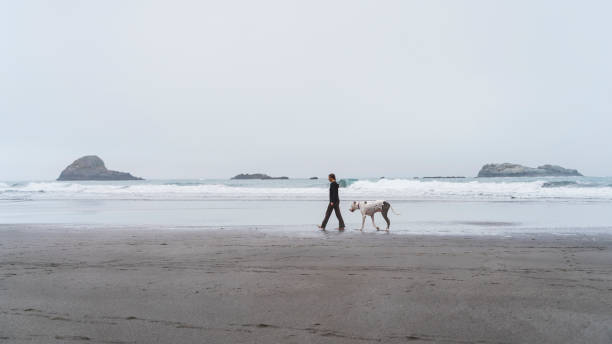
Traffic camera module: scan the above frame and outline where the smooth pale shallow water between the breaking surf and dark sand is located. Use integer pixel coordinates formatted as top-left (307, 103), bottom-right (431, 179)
top-left (0, 200), bottom-right (612, 235)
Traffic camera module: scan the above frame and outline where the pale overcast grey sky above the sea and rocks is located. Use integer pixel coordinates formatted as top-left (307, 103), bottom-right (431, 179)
top-left (0, 0), bottom-right (612, 180)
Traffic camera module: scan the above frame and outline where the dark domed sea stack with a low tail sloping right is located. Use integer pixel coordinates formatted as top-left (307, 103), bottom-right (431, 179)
top-left (57, 155), bottom-right (142, 180)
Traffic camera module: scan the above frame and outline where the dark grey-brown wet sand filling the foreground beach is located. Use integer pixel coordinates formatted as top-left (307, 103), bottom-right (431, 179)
top-left (0, 225), bottom-right (612, 343)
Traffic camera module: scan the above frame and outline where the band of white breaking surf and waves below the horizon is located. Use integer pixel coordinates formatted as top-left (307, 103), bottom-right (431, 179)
top-left (0, 179), bottom-right (612, 200)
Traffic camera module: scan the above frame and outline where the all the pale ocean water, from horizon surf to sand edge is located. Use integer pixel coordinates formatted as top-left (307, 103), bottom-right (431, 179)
top-left (0, 177), bottom-right (612, 235)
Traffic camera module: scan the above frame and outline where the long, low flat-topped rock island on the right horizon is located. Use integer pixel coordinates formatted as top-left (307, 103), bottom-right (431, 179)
top-left (478, 163), bottom-right (582, 177)
